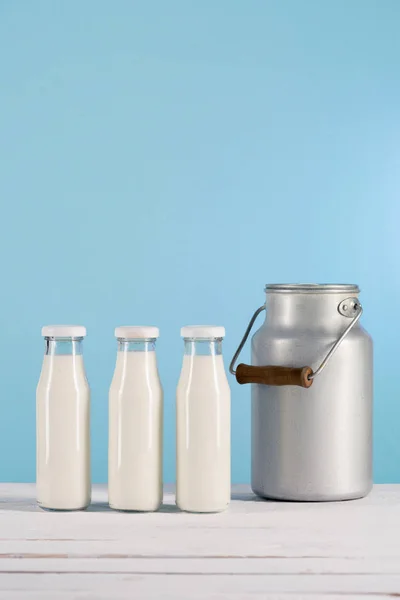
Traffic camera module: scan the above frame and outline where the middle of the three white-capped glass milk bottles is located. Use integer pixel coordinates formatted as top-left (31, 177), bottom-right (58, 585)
top-left (108, 327), bottom-right (163, 511)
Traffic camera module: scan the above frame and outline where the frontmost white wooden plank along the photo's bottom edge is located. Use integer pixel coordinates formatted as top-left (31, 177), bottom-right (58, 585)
top-left (0, 573), bottom-right (400, 600)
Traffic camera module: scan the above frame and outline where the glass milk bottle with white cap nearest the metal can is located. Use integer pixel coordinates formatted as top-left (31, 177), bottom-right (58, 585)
top-left (176, 325), bottom-right (231, 513)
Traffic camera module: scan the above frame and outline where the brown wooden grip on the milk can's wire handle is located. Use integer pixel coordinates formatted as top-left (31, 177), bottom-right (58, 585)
top-left (236, 364), bottom-right (313, 388)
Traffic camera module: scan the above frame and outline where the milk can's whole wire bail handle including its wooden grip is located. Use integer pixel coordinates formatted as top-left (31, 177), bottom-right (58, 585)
top-left (229, 298), bottom-right (363, 388)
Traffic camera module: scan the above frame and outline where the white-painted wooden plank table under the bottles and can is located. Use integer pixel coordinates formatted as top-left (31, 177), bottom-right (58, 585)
top-left (0, 484), bottom-right (400, 600)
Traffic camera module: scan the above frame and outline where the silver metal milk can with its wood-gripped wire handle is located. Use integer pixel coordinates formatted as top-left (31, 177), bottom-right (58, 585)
top-left (230, 284), bottom-right (373, 501)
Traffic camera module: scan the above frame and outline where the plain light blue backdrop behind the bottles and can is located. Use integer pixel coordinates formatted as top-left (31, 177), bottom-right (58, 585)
top-left (0, 0), bottom-right (400, 482)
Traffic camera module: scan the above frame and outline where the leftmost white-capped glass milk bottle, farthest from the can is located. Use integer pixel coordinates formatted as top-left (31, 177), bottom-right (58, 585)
top-left (36, 325), bottom-right (91, 510)
